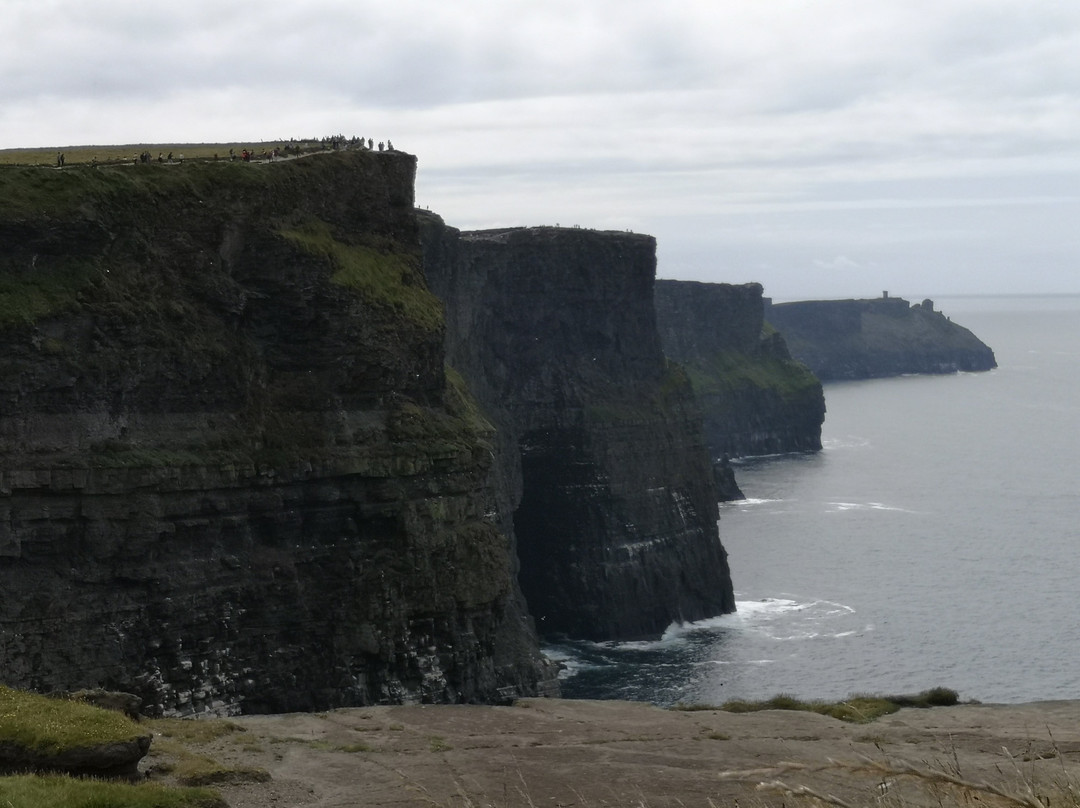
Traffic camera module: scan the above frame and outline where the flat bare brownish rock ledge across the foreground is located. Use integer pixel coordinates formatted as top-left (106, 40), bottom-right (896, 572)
top-left (147, 699), bottom-right (1080, 808)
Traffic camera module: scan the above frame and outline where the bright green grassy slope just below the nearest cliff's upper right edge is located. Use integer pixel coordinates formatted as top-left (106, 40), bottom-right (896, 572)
top-left (281, 220), bottom-right (443, 331)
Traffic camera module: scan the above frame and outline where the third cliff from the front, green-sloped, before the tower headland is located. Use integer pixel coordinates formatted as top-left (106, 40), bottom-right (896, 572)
top-left (656, 281), bottom-right (825, 458)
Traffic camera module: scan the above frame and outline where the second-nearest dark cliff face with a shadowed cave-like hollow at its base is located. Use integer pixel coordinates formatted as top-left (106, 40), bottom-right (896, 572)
top-left (421, 214), bottom-right (734, 639)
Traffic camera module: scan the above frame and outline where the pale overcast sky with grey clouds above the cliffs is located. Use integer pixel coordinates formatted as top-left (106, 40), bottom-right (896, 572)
top-left (0, 0), bottom-right (1080, 299)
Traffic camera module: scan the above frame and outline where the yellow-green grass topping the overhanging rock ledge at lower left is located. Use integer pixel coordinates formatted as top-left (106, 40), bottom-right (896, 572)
top-left (0, 685), bottom-right (147, 754)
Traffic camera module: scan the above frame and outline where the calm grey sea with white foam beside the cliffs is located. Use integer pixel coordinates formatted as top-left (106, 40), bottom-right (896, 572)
top-left (545, 296), bottom-right (1080, 705)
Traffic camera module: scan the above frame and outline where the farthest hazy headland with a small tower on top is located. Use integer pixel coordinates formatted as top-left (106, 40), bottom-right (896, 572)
top-left (766, 296), bottom-right (997, 380)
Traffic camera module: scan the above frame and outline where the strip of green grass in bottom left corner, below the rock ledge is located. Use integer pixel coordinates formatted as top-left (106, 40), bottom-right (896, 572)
top-left (0, 775), bottom-right (228, 808)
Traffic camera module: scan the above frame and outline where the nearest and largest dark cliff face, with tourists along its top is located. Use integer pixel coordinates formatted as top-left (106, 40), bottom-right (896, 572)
top-left (0, 152), bottom-right (549, 713)
